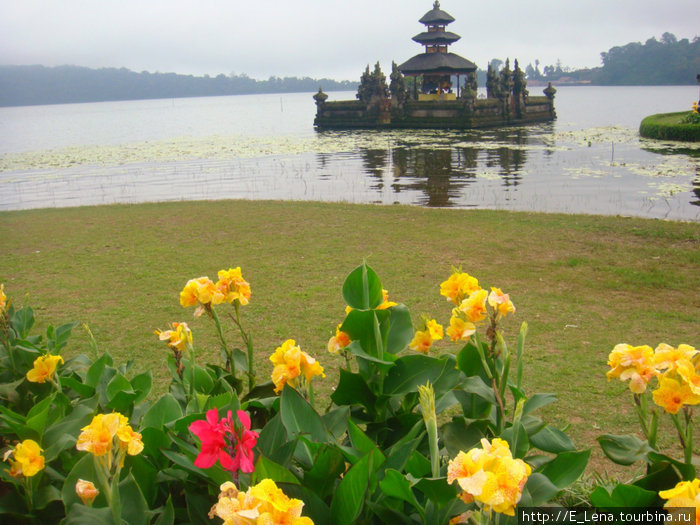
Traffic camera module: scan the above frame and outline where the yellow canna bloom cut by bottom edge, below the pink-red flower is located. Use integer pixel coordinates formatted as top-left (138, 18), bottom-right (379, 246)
top-left (209, 479), bottom-right (313, 525)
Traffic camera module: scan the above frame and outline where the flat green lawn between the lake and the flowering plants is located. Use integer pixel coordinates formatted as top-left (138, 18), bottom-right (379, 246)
top-left (0, 201), bottom-right (700, 468)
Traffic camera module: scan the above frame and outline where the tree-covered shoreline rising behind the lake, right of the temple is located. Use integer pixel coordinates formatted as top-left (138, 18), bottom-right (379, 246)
top-left (516, 33), bottom-right (700, 86)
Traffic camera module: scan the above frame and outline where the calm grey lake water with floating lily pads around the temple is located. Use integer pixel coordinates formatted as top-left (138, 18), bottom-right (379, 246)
top-left (0, 86), bottom-right (700, 222)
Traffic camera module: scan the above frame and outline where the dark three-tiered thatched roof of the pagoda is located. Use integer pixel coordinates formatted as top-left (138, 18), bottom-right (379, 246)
top-left (399, 0), bottom-right (477, 76)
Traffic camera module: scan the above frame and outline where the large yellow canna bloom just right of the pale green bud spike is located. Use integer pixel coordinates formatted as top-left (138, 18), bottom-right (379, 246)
top-left (447, 438), bottom-right (532, 516)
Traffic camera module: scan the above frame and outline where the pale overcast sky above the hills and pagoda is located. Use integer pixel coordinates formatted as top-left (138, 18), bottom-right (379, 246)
top-left (0, 0), bottom-right (700, 80)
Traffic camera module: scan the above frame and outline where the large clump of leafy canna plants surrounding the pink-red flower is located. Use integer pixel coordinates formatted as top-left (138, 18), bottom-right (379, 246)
top-left (0, 264), bottom-right (685, 525)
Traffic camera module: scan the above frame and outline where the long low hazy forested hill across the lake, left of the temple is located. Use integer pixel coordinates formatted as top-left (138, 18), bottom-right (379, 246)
top-left (0, 66), bottom-right (357, 106)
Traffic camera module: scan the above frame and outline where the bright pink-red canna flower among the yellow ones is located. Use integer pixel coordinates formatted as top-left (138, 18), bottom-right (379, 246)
top-left (189, 408), bottom-right (258, 472)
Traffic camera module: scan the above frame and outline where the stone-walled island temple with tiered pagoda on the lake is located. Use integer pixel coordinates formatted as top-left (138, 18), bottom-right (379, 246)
top-left (314, 0), bottom-right (556, 129)
